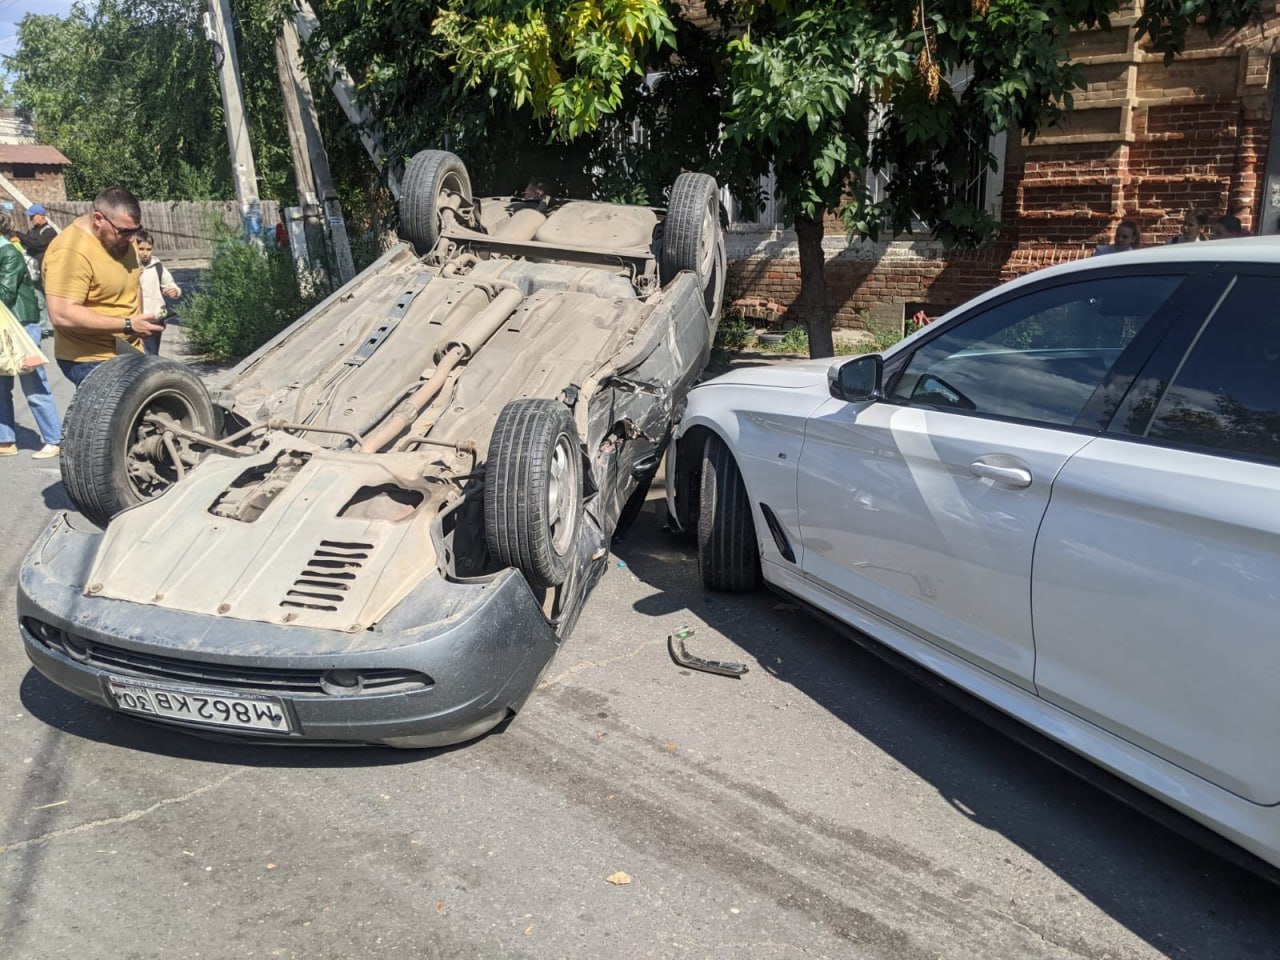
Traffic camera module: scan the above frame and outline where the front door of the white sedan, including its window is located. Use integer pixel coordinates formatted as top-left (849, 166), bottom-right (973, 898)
top-left (797, 274), bottom-right (1183, 689)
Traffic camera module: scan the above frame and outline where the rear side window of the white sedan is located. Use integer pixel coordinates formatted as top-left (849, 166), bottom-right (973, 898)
top-left (1146, 276), bottom-right (1280, 462)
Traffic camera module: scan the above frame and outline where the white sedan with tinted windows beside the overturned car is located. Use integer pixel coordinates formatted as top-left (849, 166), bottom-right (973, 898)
top-left (668, 238), bottom-right (1280, 880)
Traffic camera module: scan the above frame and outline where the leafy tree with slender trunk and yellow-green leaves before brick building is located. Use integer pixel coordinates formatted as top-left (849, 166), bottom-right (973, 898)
top-left (412, 0), bottom-right (1261, 356)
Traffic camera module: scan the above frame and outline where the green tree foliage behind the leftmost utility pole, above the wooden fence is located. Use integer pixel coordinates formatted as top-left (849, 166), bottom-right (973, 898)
top-left (5, 0), bottom-right (292, 200)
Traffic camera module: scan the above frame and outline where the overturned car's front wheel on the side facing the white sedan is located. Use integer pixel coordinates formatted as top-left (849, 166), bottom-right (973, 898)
top-left (484, 399), bottom-right (582, 589)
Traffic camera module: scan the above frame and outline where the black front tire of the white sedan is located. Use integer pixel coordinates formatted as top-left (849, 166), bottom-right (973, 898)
top-left (698, 434), bottom-right (760, 591)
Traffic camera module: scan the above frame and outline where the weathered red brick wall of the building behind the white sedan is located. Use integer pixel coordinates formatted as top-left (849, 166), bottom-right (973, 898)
top-left (728, 3), bottom-right (1280, 335)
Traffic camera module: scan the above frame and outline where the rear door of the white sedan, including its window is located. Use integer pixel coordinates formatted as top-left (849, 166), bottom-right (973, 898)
top-left (1032, 275), bottom-right (1280, 804)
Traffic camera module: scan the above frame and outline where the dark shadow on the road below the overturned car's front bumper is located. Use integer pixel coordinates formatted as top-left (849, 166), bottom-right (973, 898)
top-left (18, 667), bottom-right (478, 769)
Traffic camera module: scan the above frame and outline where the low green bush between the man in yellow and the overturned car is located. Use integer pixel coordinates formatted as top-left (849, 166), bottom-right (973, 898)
top-left (183, 236), bottom-right (328, 362)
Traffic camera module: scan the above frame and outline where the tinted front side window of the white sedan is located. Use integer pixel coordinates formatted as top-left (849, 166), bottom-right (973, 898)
top-left (890, 274), bottom-right (1184, 425)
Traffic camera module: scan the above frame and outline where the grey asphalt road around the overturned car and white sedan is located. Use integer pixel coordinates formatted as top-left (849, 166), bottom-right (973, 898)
top-left (0, 340), bottom-right (1280, 960)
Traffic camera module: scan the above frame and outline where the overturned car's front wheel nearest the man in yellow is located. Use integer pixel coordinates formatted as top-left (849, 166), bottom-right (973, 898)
top-left (60, 353), bottom-right (218, 526)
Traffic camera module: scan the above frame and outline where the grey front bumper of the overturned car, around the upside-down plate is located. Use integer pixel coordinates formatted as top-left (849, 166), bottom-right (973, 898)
top-left (18, 515), bottom-right (559, 748)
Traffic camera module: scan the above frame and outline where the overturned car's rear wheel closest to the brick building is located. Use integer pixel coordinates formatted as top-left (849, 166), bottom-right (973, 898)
top-left (659, 173), bottom-right (726, 320)
